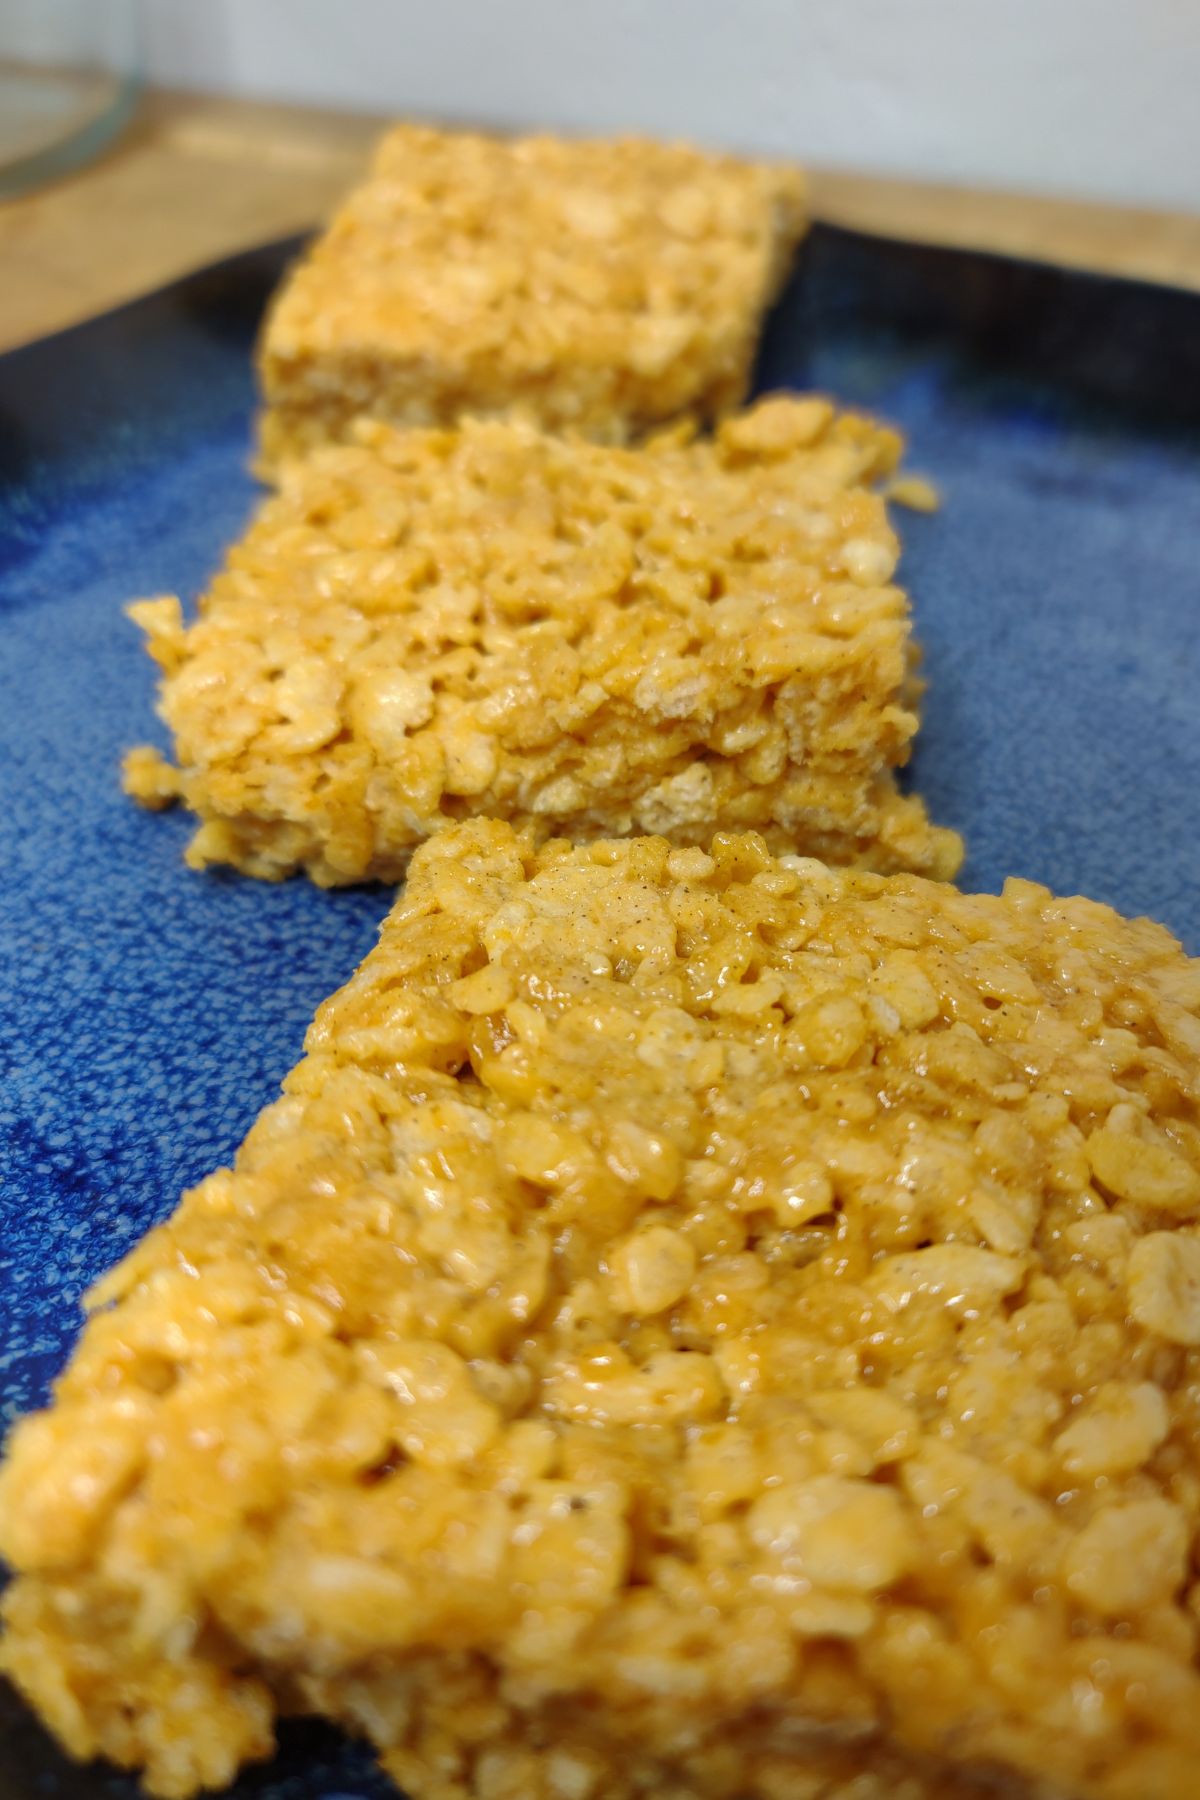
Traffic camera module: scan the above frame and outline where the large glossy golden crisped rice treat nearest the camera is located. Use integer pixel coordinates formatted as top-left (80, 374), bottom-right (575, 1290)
top-left (0, 821), bottom-right (1200, 1800)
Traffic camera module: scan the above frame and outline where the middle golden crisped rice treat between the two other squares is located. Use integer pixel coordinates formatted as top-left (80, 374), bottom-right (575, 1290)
top-left (126, 398), bottom-right (961, 884)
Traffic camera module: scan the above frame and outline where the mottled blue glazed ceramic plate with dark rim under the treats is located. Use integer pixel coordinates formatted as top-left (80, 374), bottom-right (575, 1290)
top-left (0, 229), bottom-right (1200, 1800)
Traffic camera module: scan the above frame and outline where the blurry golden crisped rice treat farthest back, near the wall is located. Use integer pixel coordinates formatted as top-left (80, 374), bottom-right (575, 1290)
top-left (259, 126), bottom-right (804, 464)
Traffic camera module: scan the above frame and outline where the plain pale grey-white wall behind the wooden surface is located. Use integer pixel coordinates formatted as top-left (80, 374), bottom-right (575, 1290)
top-left (146, 0), bottom-right (1200, 211)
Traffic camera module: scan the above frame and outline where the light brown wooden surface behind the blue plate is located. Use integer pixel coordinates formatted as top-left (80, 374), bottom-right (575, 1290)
top-left (0, 92), bottom-right (1200, 349)
